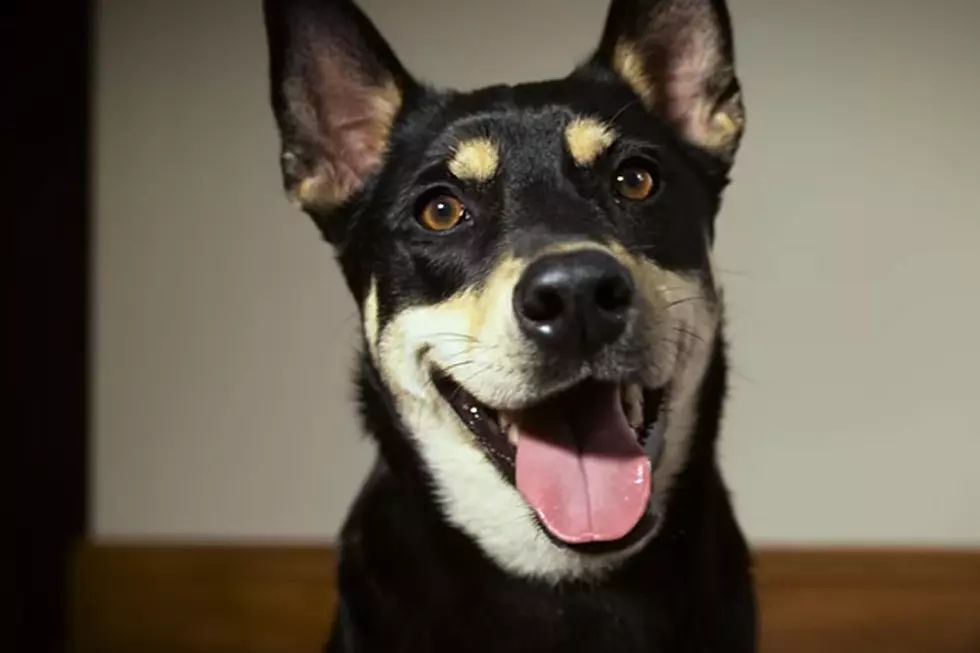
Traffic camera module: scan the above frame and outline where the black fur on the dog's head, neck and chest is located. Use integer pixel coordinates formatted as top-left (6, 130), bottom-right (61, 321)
top-left (266, 0), bottom-right (756, 653)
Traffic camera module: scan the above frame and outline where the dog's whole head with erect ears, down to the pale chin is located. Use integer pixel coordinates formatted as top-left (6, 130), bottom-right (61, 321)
top-left (266, 0), bottom-right (744, 580)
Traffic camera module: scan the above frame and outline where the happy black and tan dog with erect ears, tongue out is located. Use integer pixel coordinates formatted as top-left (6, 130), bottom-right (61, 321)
top-left (263, 0), bottom-right (756, 653)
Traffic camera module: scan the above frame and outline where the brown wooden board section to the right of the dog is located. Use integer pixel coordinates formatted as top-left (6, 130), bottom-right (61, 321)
top-left (756, 549), bottom-right (980, 653)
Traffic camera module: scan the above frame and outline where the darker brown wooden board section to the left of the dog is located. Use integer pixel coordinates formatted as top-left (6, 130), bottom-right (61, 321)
top-left (71, 545), bottom-right (336, 653)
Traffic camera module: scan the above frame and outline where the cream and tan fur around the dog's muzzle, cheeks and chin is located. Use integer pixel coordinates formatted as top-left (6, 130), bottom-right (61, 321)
top-left (364, 241), bottom-right (720, 582)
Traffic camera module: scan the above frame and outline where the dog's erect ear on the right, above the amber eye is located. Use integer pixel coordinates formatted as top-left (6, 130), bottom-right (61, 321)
top-left (593, 0), bottom-right (745, 164)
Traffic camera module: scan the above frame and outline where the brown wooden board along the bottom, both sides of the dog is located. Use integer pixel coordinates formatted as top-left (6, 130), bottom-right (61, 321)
top-left (71, 544), bottom-right (980, 653)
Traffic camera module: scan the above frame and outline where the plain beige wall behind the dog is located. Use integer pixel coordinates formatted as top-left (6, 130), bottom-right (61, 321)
top-left (92, 0), bottom-right (980, 544)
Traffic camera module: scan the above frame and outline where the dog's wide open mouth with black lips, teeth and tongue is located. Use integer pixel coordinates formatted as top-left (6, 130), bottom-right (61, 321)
top-left (433, 373), bottom-right (666, 552)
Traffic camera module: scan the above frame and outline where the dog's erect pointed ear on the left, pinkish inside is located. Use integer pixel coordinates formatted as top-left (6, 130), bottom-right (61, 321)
top-left (263, 0), bottom-right (411, 211)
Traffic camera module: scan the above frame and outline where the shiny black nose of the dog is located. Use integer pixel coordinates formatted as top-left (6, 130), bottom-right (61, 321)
top-left (514, 250), bottom-right (635, 355)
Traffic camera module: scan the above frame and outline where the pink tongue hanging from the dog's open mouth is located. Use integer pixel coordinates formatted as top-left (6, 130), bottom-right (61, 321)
top-left (516, 384), bottom-right (650, 544)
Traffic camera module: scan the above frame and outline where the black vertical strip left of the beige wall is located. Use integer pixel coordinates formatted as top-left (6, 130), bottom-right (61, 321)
top-left (7, 0), bottom-right (93, 653)
